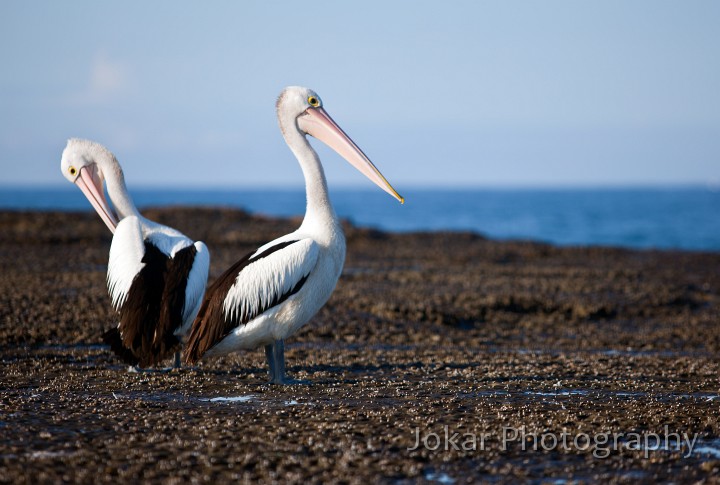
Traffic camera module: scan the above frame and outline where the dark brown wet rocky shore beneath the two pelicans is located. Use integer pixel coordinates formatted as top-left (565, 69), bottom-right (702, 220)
top-left (0, 208), bottom-right (720, 484)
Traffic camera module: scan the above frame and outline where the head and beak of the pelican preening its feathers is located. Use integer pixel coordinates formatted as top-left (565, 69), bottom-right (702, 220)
top-left (60, 138), bottom-right (122, 232)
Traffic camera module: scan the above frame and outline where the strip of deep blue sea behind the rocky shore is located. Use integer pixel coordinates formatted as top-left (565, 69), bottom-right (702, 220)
top-left (0, 185), bottom-right (720, 251)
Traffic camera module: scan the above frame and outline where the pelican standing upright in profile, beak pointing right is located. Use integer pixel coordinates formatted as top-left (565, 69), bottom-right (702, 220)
top-left (185, 86), bottom-right (404, 384)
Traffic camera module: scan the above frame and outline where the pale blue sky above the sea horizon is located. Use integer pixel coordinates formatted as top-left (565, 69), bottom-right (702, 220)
top-left (0, 0), bottom-right (720, 187)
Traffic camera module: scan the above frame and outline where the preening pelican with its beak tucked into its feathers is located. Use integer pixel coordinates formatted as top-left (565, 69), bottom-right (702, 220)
top-left (61, 139), bottom-right (210, 367)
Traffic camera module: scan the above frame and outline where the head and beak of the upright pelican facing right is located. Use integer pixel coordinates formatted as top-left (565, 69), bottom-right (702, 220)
top-left (276, 86), bottom-right (405, 203)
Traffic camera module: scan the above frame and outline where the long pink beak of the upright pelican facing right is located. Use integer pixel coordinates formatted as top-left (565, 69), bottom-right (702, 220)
top-left (298, 108), bottom-right (405, 204)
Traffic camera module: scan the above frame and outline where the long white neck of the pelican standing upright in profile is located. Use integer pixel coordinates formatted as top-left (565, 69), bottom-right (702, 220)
top-left (280, 116), bottom-right (339, 228)
